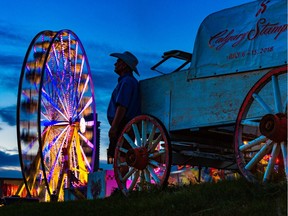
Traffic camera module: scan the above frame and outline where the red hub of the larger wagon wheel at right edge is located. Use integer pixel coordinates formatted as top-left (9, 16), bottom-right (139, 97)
top-left (260, 113), bottom-right (287, 142)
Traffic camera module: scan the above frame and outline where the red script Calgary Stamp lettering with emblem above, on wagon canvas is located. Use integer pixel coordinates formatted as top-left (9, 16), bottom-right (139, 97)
top-left (209, 1), bottom-right (288, 50)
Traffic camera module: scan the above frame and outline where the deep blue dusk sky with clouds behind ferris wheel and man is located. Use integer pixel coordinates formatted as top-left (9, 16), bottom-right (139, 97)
top-left (0, 0), bottom-right (251, 177)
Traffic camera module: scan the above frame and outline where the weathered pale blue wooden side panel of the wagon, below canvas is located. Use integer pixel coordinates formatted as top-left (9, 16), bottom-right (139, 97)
top-left (140, 69), bottom-right (276, 131)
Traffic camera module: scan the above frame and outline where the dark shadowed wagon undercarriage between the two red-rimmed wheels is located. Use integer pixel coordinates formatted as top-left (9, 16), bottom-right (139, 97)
top-left (170, 125), bottom-right (237, 170)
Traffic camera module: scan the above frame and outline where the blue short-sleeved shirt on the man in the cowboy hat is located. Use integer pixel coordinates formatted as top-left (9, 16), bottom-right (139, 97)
top-left (107, 74), bottom-right (141, 124)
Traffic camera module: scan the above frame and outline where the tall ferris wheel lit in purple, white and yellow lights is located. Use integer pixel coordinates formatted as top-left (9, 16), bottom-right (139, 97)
top-left (17, 30), bottom-right (97, 201)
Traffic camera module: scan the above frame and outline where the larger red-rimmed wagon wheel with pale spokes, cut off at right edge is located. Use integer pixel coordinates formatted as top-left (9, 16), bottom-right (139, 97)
top-left (234, 66), bottom-right (287, 182)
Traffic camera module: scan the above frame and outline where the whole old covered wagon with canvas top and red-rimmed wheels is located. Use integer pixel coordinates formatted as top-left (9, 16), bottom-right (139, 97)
top-left (114, 0), bottom-right (287, 194)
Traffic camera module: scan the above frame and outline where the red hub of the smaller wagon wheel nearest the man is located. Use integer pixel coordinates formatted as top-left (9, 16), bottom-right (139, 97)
top-left (126, 147), bottom-right (148, 170)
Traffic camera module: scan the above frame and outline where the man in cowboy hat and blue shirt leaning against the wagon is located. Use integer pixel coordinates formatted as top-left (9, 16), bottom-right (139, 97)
top-left (107, 51), bottom-right (141, 163)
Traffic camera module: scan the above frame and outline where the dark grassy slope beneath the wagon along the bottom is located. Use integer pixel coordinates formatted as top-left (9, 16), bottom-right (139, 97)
top-left (0, 179), bottom-right (287, 216)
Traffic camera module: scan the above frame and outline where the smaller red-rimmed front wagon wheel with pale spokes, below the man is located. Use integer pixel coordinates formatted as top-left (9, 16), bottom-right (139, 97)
top-left (114, 115), bottom-right (171, 195)
